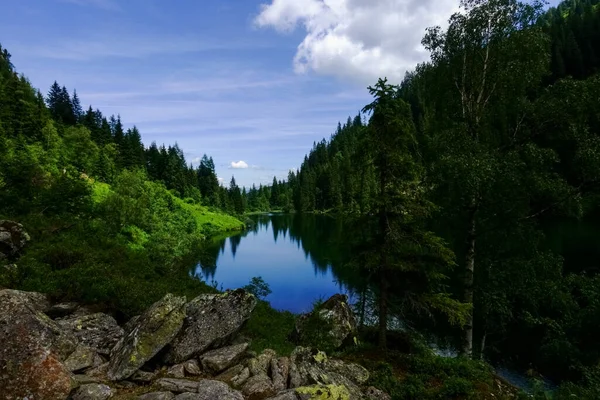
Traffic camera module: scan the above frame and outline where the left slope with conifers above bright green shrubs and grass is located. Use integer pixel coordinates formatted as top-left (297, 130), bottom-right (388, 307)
top-left (0, 43), bottom-right (243, 317)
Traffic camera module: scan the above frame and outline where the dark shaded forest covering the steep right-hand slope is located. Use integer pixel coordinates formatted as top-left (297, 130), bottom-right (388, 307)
top-left (279, 0), bottom-right (600, 397)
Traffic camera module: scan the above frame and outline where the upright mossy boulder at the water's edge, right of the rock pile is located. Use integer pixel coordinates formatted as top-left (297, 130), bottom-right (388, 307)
top-left (292, 294), bottom-right (356, 349)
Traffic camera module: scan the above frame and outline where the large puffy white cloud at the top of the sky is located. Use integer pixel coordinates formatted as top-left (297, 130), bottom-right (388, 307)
top-left (255, 0), bottom-right (459, 84)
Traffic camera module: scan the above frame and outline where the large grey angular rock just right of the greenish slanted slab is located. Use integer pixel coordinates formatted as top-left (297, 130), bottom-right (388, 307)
top-left (165, 289), bottom-right (256, 364)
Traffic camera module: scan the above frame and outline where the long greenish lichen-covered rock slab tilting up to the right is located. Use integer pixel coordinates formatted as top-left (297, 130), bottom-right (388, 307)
top-left (107, 294), bottom-right (185, 380)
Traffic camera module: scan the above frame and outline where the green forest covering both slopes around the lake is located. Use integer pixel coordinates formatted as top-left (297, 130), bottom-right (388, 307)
top-left (0, 0), bottom-right (600, 399)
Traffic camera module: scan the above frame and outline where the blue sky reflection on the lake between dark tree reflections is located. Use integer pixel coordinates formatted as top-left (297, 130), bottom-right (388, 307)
top-left (196, 217), bottom-right (346, 313)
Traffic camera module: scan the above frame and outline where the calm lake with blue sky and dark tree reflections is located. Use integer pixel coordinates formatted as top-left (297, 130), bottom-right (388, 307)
top-left (195, 214), bottom-right (358, 313)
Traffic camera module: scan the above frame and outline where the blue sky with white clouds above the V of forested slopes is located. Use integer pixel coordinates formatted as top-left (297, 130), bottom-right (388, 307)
top-left (0, 0), bottom-right (556, 186)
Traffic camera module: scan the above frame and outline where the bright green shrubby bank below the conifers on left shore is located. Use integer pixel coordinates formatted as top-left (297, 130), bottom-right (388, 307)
top-left (0, 171), bottom-right (244, 319)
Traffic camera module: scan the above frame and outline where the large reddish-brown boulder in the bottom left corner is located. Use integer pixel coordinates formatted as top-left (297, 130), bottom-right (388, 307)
top-left (0, 290), bottom-right (76, 399)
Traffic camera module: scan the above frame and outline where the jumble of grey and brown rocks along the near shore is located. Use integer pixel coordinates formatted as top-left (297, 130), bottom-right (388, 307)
top-left (0, 289), bottom-right (389, 400)
